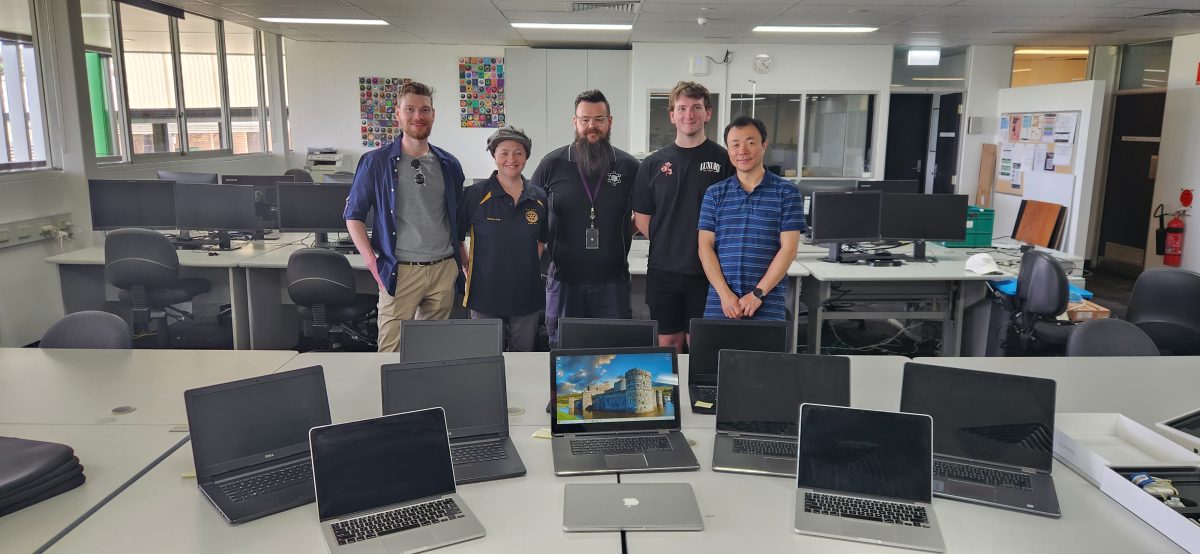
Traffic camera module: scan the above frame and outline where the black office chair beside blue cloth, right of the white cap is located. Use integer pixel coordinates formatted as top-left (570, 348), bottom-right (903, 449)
top-left (1001, 251), bottom-right (1075, 356)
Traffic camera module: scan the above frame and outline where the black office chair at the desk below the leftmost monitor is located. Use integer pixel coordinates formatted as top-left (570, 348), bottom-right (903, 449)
top-left (104, 229), bottom-right (212, 347)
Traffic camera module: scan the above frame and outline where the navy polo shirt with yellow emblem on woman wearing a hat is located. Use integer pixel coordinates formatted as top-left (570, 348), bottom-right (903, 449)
top-left (457, 171), bottom-right (550, 315)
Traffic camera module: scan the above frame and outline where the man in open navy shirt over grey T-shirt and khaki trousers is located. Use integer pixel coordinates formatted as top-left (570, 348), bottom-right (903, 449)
top-left (343, 82), bottom-right (463, 353)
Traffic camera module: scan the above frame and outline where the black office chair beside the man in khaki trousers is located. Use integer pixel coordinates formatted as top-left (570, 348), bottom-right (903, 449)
top-left (287, 248), bottom-right (378, 349)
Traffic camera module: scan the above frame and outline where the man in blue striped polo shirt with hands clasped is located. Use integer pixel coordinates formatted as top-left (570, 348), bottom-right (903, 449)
top-left (698, 115), bottom-right (804, 319)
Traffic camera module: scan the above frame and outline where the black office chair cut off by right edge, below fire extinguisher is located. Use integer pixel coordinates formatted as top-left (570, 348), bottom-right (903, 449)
top-left (1126, 267), bottom-right (1200, 356)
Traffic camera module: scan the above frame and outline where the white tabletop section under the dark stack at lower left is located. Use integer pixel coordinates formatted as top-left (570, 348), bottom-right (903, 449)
top-left (0, 423), bottom-right (186, 553)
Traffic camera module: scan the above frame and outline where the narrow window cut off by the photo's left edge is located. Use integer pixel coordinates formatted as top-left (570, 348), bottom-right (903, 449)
top-left (0, 0), bottom-right (49, 171)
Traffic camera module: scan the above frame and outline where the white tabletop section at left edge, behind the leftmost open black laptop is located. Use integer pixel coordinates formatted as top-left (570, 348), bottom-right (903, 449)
top-left (0, 348), bottom-right (295, 424)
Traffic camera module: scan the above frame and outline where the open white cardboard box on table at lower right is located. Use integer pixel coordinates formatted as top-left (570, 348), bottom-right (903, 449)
top-left (1054, 414), bottom-right (1200, 553)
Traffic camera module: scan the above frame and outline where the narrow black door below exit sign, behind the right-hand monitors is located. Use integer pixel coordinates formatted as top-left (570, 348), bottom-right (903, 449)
top-left (883, 94), bottom-right (934, 182)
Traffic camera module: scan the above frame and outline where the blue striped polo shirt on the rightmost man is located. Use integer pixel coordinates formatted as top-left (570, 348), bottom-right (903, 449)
top-left (697, 171), bottom-right (804, 319)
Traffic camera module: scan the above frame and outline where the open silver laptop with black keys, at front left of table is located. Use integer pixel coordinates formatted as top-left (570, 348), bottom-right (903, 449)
top-left (308, 408), bottom-right (485, 554)
